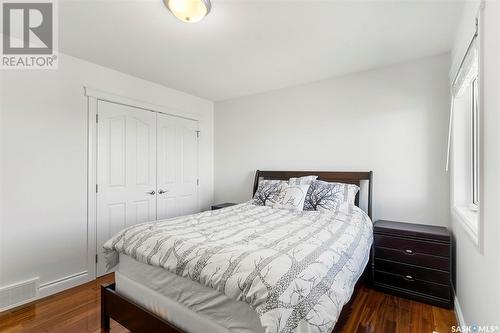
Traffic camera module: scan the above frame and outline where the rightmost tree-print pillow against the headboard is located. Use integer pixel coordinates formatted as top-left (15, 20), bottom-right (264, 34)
top-left (304, 180), bottom-right (359, 211)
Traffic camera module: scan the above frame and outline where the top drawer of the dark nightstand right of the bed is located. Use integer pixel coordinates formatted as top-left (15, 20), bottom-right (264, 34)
top-left (375, 234), bottom-right (450, 258)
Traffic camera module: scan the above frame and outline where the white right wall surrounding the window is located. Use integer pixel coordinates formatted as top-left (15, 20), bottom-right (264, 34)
top-left (450, 1), bottom-right (500, 326)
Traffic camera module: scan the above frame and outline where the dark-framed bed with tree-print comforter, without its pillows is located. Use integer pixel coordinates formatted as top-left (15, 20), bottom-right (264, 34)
top-left (101, 171), bottom-right (373, 333)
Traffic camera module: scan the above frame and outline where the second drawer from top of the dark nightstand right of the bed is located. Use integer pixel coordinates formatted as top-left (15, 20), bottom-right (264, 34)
top-left (375, 247), bottom-right (450, 271)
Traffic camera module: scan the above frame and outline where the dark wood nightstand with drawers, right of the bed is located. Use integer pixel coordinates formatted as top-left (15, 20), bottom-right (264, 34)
top-left (372, 221), bottom-right (453, 308)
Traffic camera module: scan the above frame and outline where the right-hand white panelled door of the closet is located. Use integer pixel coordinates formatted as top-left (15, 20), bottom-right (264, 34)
top-left (157, 113), bottom-right (198, 220)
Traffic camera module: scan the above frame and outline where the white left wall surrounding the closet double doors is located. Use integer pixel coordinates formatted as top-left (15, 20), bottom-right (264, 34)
top-left (0, 54), bottom-right (213, 304)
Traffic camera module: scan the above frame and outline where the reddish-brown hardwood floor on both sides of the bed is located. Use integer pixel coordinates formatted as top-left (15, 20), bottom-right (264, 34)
top-left (0, 275), bottom-right (457, 333)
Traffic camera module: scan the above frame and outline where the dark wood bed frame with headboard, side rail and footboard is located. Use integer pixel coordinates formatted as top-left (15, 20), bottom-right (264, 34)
top-left (101, 170), bottom-right (373, 333)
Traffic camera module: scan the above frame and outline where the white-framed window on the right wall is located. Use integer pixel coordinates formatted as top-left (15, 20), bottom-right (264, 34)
top-left (450, 39), bottom-right (481, 244)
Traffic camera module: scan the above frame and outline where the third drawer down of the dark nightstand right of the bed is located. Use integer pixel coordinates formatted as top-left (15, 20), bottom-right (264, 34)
top-left (375, 259), bottom-right (450, 285)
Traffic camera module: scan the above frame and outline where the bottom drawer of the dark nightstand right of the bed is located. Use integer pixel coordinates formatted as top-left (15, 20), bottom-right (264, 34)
top-left (374, 271), bottom-right (450, 300)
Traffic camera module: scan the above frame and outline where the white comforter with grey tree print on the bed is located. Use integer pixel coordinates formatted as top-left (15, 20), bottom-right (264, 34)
top-left (104, 203), bottom-right (372, 333)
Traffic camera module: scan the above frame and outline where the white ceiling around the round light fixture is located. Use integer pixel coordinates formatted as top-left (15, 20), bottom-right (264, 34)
top-left (59, 0), bottom-right (463, 101)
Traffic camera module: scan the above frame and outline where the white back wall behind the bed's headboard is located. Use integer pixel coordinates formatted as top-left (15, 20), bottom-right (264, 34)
top-left (215, 55), bottom-right (450, 225)
